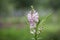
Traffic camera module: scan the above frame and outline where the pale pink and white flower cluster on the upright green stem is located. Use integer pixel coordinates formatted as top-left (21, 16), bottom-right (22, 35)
top-left (27, 10), bottom-right (39, 28)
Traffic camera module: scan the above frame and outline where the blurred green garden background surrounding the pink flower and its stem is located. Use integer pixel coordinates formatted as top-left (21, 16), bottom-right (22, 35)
top-left (0, 0), bottom-right (60, 40)
